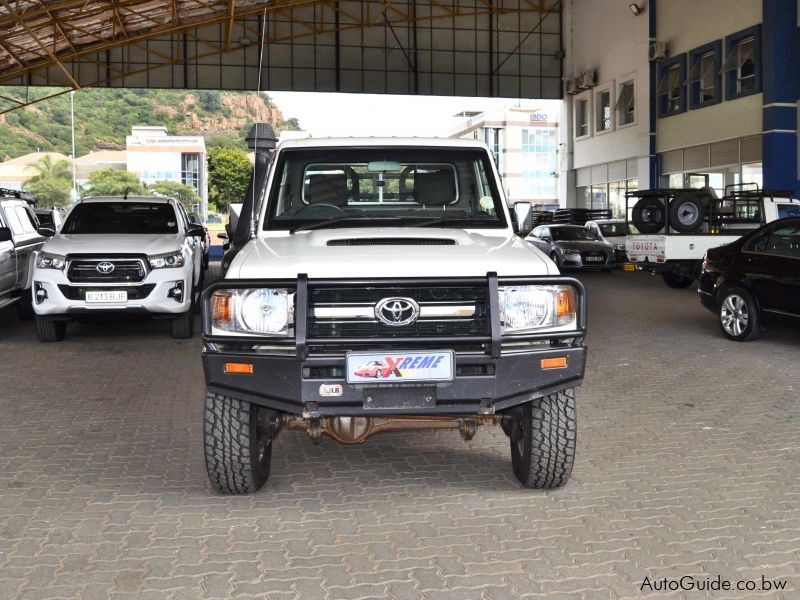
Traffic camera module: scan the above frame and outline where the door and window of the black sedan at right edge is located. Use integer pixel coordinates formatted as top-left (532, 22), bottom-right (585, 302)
top-left (742, 220), bottom-right (800, 317)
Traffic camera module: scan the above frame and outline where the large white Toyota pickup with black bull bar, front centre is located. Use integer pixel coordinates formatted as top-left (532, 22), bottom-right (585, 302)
top-left (203, 139), bottom-right (586, 493)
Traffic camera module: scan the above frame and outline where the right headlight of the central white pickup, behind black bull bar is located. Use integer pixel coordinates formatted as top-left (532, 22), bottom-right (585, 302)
top-left (498, 285), bottom-right (577, 333)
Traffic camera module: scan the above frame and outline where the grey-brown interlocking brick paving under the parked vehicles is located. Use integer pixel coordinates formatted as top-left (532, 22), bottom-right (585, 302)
top-left (0, 272), bottom-right (800, 600)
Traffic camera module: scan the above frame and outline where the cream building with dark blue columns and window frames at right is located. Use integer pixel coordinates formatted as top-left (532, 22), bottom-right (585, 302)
top-left (561, 0), bottom-right (800, 216)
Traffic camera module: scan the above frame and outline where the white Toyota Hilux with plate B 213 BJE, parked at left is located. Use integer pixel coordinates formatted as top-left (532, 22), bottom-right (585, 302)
top-left (32, 197), bottom-right (204, 342)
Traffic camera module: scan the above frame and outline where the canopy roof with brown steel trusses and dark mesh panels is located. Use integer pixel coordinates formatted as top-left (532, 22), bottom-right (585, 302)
top-left (0, 0), bottom-right (563, 112)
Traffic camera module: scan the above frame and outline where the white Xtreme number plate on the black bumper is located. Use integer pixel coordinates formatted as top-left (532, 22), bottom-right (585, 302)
top-left (345, 350), bottom-right (455, 386)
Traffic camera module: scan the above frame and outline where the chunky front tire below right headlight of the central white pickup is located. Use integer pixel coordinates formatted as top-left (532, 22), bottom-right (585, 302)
top-left (510, 388), bottom-right (577, 489)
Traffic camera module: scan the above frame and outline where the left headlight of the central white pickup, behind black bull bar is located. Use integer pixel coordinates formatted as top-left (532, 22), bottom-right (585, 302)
top-left (211, 288), bottom-right (294, 335)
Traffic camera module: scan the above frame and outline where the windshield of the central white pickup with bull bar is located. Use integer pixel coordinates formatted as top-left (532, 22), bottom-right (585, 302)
top-left (264, 147), bottom-right (506, 231)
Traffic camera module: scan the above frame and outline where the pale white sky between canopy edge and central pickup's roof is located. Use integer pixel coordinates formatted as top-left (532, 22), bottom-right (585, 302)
top-left (268, 92), bottom-right (561, 137)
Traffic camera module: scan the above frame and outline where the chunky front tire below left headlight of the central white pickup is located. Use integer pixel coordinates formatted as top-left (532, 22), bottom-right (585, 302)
top-left (204, 392), bottom-right (277, 494)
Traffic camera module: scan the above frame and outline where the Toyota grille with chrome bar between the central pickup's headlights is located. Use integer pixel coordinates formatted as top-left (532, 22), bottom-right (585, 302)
top-left (308, 286), bottom-right (490, 340)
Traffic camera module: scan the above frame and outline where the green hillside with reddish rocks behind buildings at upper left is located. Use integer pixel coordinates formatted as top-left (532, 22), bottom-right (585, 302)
top-left (0, 88), bottom-right (299, 160)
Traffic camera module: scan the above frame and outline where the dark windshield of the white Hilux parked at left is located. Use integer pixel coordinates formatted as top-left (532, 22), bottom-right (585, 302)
top-left (61, 202), bottom-right (178, 233)
